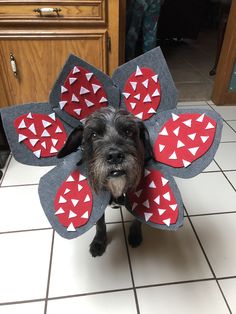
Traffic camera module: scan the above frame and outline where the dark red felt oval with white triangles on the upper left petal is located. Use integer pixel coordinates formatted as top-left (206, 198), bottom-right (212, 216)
top-left (59, 66), bottom-right (108, 120)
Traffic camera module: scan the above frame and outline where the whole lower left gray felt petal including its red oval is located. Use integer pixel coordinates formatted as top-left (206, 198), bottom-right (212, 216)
top-left (38, 151), bottom-right (110, 239)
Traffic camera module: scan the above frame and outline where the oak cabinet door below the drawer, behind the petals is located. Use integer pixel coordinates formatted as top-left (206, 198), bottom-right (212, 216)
top-left (0, 30), bottom-right (107, 107)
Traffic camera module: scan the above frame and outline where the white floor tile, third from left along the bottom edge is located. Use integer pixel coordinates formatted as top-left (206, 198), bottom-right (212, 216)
top-left (137, 281), bottom-right (229, 314)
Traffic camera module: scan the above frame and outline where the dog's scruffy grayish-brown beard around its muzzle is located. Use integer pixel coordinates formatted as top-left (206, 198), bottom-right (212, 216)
top-left (86, 155), bottom-right (143, 198)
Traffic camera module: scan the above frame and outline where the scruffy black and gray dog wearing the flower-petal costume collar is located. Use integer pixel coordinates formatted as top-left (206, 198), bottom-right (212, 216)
top-left (57, 107), bottom-right (153, 257)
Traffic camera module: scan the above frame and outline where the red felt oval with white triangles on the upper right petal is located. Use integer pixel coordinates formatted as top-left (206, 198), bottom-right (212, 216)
top-left (123, 67), bottom-right (161, 120)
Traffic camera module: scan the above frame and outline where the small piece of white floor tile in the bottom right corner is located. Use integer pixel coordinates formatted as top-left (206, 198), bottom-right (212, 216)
top-left (219, 278), bottom-right (236, 314)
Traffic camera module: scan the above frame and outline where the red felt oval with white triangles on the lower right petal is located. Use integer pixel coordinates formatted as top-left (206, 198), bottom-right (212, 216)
top-left (129, 169), bottom-right (179, 226)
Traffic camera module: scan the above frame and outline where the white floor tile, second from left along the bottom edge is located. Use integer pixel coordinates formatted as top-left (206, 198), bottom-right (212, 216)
top-left (47, 291), bottom-right (137, 314)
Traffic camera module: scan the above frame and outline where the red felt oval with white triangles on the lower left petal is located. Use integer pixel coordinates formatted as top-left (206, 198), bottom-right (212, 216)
top-left (54, 170), bottom-right (93, 231)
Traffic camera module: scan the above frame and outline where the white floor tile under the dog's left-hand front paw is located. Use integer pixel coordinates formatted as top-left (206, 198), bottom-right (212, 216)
top-left (49, 223), bottom-right (132, 297)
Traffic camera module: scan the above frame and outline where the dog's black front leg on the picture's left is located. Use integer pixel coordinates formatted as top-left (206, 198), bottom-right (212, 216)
top-left (90, 214), bottom-right (107, 257)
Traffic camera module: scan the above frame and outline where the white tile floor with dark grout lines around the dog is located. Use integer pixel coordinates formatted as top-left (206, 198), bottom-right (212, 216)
top-left (0, 102), bottom-right (236, 314)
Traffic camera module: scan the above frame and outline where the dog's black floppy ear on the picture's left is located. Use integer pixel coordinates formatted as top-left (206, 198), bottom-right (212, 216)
top-left (57, 125), bottom-right (84, 158)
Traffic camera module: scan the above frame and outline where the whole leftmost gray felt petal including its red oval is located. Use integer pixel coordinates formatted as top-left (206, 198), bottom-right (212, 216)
top-left (0, 103), bottom-right (72, 166)
